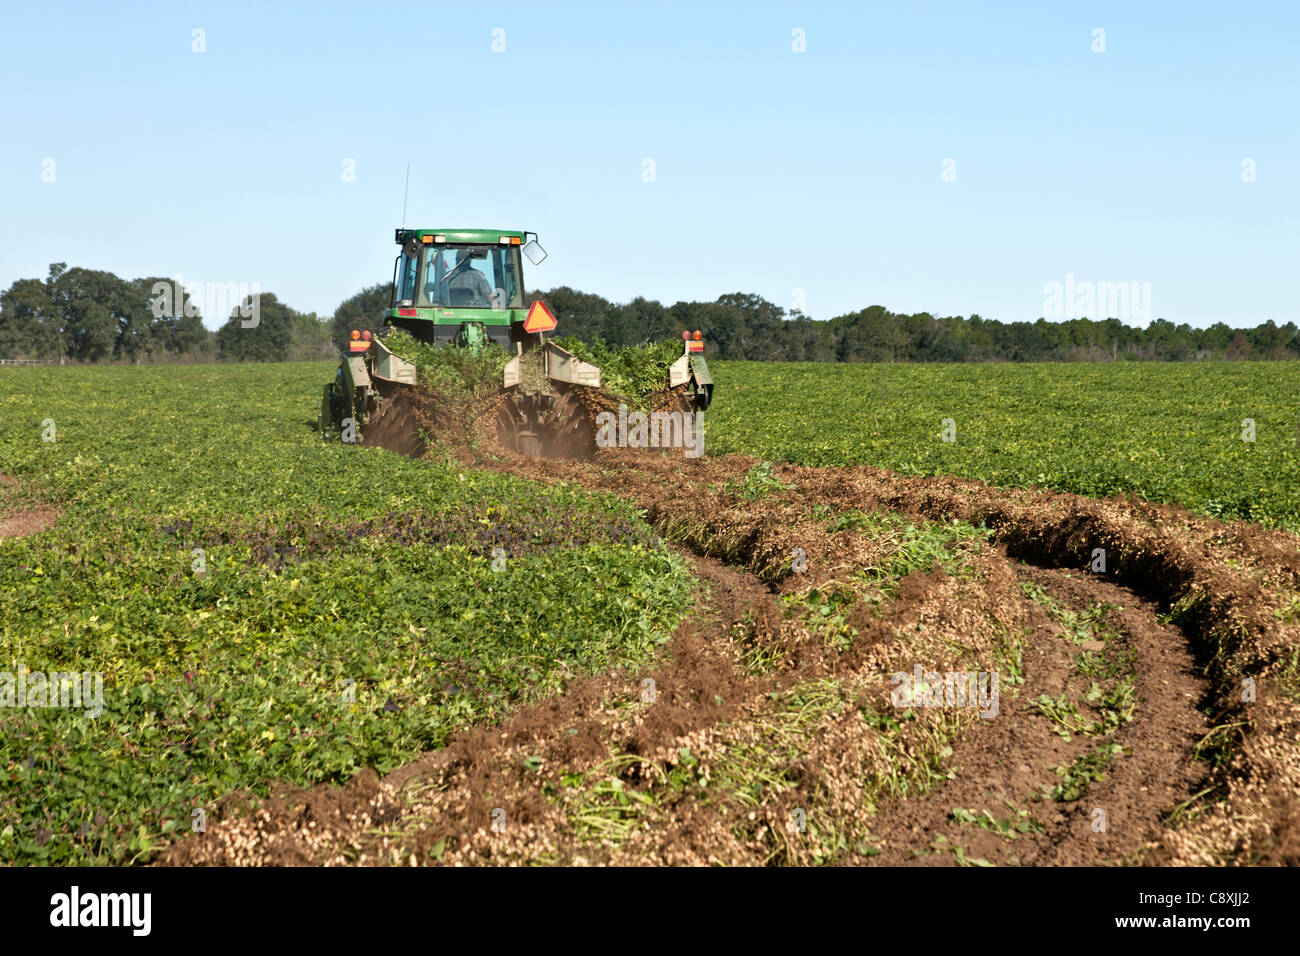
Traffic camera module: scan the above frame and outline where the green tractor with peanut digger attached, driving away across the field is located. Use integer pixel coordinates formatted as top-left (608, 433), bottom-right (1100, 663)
top-left (319, 229), bottom-right (712, 458)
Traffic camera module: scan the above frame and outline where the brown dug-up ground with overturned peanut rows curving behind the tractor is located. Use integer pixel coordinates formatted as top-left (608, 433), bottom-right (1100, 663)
top-left (164, 400), bottom-right (1300, 865)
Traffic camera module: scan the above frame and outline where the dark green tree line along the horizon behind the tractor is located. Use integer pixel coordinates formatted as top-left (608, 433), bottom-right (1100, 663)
top-left (0, 263), bottom-right (1300, 363)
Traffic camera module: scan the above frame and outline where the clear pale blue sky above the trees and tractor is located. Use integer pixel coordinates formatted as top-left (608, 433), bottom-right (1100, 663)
top-left (0, 0), bottom-right (1300, 325)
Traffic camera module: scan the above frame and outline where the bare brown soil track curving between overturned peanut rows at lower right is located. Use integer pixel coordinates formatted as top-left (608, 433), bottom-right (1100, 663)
top-left (872, 567), bottom-right (1209, 866)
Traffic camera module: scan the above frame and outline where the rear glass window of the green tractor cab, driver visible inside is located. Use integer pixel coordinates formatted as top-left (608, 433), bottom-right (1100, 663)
top-left (419, 243), bottom-right (524, 310)
